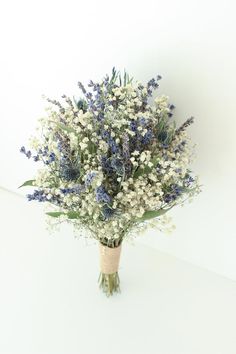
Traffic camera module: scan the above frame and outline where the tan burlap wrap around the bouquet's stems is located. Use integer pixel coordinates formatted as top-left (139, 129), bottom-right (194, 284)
top-left (99, 243), bottom-right (121, 274)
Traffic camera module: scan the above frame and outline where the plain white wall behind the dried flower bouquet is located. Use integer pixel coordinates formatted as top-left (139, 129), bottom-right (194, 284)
top-left (0, 0), bottom-right (236, 279)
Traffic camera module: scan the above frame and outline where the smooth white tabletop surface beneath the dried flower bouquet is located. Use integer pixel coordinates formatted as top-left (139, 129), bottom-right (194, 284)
top-left (0, 190), bottom-right (236, 354)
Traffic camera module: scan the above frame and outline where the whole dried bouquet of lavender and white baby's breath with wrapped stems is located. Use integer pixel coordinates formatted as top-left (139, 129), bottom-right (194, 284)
top-left (20, 68), bottom-right (200, 295)
